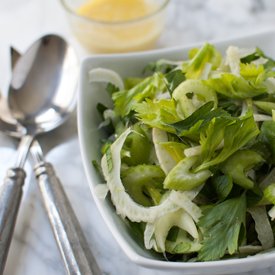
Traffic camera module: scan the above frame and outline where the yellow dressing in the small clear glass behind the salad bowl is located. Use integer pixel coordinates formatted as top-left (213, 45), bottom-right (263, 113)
top-left (71, 0), bottom-right (168, 53)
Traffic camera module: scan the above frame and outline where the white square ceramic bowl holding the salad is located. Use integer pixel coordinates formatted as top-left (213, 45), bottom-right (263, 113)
top-left (78, 30), bottom-right (275, 274)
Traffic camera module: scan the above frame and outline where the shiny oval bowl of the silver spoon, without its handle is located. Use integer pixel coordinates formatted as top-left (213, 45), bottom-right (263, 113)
top-left (8, 35), bottom-right (79, 136)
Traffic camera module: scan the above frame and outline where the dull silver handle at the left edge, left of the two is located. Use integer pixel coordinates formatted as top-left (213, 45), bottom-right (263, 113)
top-left (0, 168), bottom-right (26, 274)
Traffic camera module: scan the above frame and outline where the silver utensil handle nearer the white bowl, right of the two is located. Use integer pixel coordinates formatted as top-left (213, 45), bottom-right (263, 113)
top-left (34, 162), bottom-right (102, 275)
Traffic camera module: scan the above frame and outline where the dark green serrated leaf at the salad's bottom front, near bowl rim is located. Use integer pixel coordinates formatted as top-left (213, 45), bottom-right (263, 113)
top-left (197, 192), bottom-right (246, 261)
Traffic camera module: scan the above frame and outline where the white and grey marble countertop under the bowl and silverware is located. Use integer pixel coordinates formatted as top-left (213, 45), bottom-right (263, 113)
top-left (0, 0), bottom-right (275, 275)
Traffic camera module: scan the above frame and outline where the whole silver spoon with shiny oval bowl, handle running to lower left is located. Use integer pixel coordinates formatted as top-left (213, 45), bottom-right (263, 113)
top-left (0, 35), bottom-right (79, 274)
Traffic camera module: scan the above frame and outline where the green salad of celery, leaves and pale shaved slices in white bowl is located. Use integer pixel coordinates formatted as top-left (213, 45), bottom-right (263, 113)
top-left (89, 43), bottom-right (275, 262)
